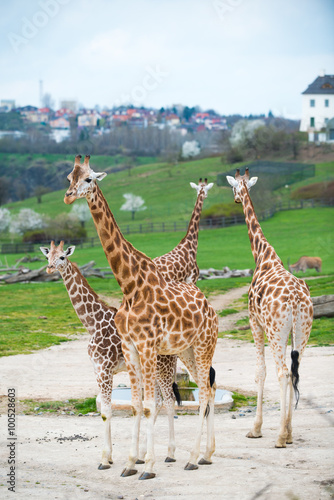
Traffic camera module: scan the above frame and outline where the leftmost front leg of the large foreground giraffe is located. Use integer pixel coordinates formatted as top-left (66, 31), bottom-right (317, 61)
top-left (121, 342), bottom-right (143, 477)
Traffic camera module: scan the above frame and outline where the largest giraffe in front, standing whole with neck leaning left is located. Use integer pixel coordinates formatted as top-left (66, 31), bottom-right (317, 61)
top-left (64, 156), bottom-right (218, 479)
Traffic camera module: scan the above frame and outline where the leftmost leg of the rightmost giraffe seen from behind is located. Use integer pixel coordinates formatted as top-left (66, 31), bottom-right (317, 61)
top-left (247, 315), bottom-right (266, 438)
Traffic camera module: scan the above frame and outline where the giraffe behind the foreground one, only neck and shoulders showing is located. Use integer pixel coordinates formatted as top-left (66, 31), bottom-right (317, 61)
top-left (153, 179), bottom-right (213, 285)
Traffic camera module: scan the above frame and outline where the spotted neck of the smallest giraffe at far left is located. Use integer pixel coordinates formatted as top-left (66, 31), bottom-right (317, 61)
top-left (60, 260), bottom-right (99, 331)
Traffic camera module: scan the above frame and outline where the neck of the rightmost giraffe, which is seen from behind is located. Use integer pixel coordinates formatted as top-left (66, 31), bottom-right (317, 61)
top-left (239, 183), bottom-right (269, 264)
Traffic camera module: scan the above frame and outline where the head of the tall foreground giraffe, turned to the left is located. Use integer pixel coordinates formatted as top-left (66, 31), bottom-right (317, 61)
top-left (64, 155), bottom-right (107, 205)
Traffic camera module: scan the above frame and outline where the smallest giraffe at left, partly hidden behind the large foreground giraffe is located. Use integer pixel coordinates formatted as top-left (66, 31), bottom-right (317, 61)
top-left (40, 241), bottom-right (180, 470)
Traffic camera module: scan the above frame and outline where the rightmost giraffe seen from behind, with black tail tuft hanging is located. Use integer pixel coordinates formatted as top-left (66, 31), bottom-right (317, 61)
top-left (227, 168), bottom-right (313, 448)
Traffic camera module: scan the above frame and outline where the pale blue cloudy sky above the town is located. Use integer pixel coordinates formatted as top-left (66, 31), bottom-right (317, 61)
top-left (0, 0), bottom-right (334, 119)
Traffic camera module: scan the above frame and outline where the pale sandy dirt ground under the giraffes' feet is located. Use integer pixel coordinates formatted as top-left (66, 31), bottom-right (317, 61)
top-left (0, 287), bottom-right (334, 500)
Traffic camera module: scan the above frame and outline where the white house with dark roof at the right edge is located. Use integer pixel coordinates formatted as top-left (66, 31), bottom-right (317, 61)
top-left (299, 75), bottom-right (334, 142)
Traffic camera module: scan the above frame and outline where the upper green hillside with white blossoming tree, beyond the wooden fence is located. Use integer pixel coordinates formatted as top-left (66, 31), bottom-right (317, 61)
top-left (0, 155), bottom-right (334, 236)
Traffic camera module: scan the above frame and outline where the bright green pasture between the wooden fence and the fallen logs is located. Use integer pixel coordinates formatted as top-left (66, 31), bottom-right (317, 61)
top-left (4, 208), bottom-right (334, 275)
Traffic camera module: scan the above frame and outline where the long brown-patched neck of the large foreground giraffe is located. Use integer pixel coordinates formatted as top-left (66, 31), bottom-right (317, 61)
top-left (87, 185), bottom-right (163, 300)
